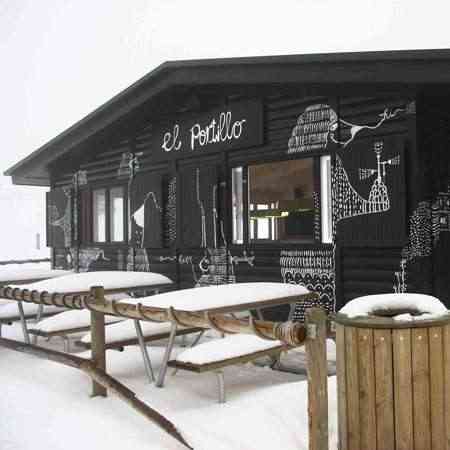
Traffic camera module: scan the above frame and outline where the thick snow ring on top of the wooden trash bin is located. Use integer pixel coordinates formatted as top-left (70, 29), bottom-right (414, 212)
top-left (339, 293), bottom-right (448, 320)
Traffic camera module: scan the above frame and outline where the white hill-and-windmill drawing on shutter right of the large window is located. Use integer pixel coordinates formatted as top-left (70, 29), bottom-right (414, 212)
top-left (332, 142), bottom-right (400, 227)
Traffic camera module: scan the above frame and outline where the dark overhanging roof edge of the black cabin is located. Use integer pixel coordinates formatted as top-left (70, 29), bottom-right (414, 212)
top-left (5, 49), bottom-right (450, 186)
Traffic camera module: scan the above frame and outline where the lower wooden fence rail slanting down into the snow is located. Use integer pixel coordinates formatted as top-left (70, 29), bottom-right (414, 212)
top-left (0, 338), bottom-right (193, 449)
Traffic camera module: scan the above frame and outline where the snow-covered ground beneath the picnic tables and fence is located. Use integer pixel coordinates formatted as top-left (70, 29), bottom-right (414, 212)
top-left (0, 320), bottom-right (336, 450)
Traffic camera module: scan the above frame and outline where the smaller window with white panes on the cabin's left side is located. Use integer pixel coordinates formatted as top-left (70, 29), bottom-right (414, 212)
top-left (92, 186), bottom-right (125, 242)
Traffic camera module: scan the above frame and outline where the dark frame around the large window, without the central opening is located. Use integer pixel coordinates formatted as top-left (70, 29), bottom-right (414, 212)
top-left (229, 151), bottom-right (333, 247)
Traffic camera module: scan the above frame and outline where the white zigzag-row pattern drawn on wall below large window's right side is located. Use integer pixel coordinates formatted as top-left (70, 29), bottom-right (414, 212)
top-left (280, 249), bottom-right (335, 321)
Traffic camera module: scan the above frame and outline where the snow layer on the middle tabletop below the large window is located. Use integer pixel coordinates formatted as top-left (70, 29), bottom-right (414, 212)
top-left (134, 282), bottom-right (310, 311)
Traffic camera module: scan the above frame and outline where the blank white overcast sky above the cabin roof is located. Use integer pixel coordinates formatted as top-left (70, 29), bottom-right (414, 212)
top-left (0, 0), bottom-right (450, 258)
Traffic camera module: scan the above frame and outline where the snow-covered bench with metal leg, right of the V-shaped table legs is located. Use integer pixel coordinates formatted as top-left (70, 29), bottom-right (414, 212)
top-left (168, 334), bottom-right (288, 403)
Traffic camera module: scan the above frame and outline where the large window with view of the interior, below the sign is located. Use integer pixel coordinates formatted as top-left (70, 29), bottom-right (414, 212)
top-left (232, 156), bottom-right (332, 244)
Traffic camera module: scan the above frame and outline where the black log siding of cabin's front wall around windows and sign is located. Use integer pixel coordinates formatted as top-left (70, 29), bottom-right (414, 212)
top-left (45, 87), bottom-right (432, 314)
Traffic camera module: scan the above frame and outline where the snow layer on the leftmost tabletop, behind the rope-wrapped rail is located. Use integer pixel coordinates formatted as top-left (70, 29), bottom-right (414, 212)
top-left (9, 270), bottom-right (172, 294)
